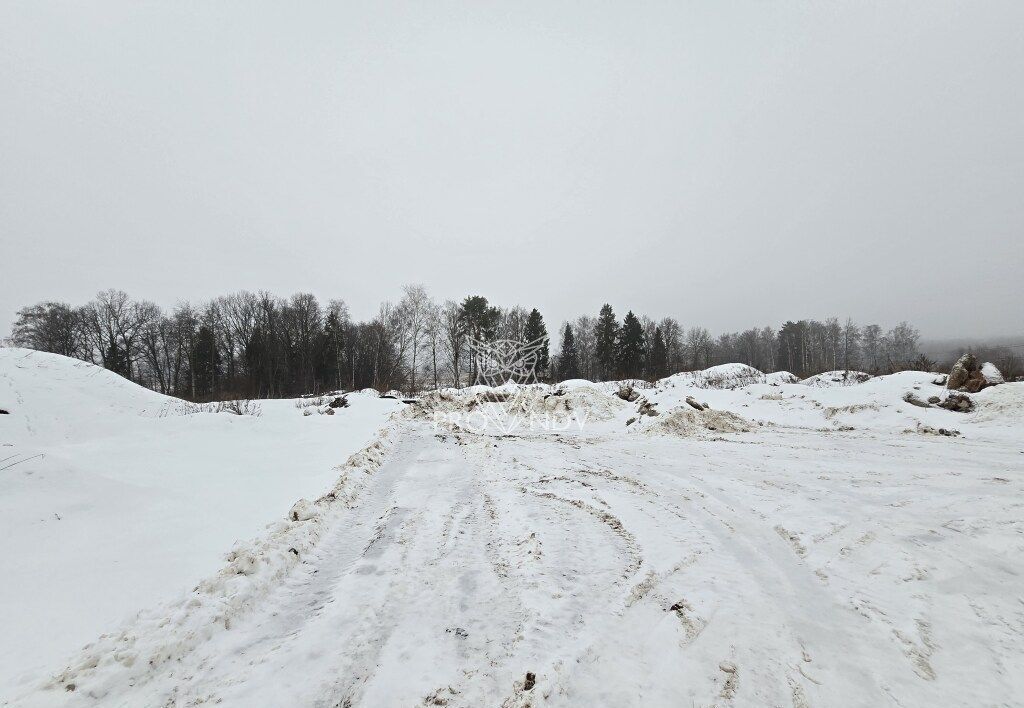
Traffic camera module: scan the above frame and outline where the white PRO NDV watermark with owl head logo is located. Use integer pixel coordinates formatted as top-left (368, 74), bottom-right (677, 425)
top-left (434, 337), bottom-right (587, 435)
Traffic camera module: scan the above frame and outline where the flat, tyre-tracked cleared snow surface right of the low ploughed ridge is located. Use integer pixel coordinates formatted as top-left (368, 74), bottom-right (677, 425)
top-left (29, 422), bottom-right (1024, 708)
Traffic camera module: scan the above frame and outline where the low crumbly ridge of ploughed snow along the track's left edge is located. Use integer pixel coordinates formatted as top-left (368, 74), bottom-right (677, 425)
top-left (29, 432), bottom-right (392, 699)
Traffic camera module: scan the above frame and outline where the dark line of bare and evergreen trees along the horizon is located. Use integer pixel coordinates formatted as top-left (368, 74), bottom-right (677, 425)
top-left (9, 285), bottom-right (1021, 401)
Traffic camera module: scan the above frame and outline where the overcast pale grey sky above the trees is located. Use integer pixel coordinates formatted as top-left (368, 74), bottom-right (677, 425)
top-left (0, 0), bottom-right (1024, 336)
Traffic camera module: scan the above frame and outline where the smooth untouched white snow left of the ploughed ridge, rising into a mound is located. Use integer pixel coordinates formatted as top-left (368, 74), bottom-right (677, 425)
top-left (0, 348), bottom-right (399, 697)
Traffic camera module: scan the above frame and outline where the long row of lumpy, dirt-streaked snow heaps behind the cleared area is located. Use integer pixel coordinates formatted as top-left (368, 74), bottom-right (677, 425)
top-left (407, 364), bottom-right (1014, 436)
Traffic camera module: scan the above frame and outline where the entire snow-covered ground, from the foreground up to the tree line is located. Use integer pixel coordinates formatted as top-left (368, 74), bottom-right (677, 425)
top-left (0, 349), bottom-right (1024, 708)
